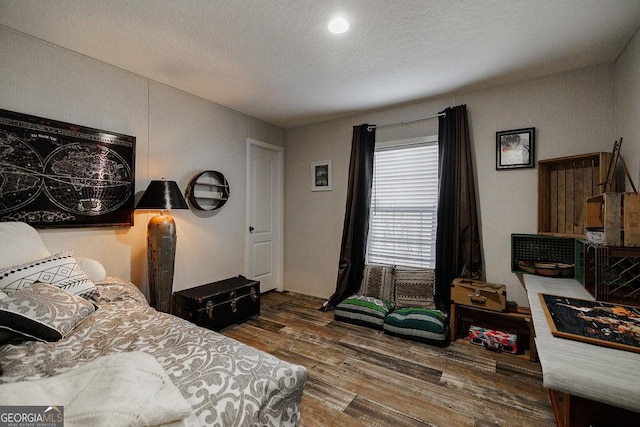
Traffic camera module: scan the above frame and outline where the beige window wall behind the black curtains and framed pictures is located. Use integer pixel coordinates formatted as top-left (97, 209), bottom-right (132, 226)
top-left (285, 64), bottom-right (614, 305)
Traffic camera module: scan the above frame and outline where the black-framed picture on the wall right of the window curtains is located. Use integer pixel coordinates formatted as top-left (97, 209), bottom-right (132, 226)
top-left (496, 128), bottom-right (536, 169)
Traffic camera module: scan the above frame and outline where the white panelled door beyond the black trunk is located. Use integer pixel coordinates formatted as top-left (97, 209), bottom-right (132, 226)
top-left (246, 139), bottom-right (283, 292)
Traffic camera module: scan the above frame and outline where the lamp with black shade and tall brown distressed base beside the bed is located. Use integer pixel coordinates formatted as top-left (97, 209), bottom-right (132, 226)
top-left (136, 178), bottom-right (189, 313)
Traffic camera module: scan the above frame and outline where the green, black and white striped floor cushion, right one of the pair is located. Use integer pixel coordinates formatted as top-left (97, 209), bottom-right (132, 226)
top-left (383, 307), bottom-right (449, 342)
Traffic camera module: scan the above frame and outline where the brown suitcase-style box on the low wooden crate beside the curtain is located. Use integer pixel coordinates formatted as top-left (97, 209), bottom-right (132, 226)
top-left (451, 278), bottom-right (507, 311)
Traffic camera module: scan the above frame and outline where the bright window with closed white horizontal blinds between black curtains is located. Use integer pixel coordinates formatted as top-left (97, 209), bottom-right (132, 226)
top-left (367, 136), bottom-right (438, 268)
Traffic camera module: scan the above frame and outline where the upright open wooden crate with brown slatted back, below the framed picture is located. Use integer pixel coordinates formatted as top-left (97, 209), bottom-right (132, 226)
top-left (538, 153), bottom-right (617, 237)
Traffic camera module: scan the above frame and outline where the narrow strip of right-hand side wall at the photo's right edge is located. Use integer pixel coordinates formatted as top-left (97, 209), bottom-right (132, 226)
top-left (615, 31), bottom-right (640, 186)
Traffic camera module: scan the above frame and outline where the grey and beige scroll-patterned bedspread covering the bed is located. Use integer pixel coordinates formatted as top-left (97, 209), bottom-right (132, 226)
top-left (0, 278), bottom-right (306, 427)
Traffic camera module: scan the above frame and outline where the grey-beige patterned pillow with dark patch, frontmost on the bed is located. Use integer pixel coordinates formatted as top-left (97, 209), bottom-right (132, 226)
top-left (0, 283), bottom-right (95, 341)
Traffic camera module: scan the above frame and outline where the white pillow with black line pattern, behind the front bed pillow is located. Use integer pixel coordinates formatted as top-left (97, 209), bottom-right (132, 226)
top-left (0, 251), bottom-right (98, 299)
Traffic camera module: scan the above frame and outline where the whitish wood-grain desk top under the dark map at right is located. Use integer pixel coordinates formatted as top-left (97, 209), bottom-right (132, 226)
top-left (523, 274), bottom-right (640, 412)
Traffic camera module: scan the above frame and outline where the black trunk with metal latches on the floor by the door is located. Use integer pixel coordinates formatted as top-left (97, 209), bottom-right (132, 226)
top-left (173, 276), bottom-right (260, 331)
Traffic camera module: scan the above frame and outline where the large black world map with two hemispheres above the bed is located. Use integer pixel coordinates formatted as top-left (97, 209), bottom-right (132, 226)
top-left (0, 109), bottom-right (136, 227)
